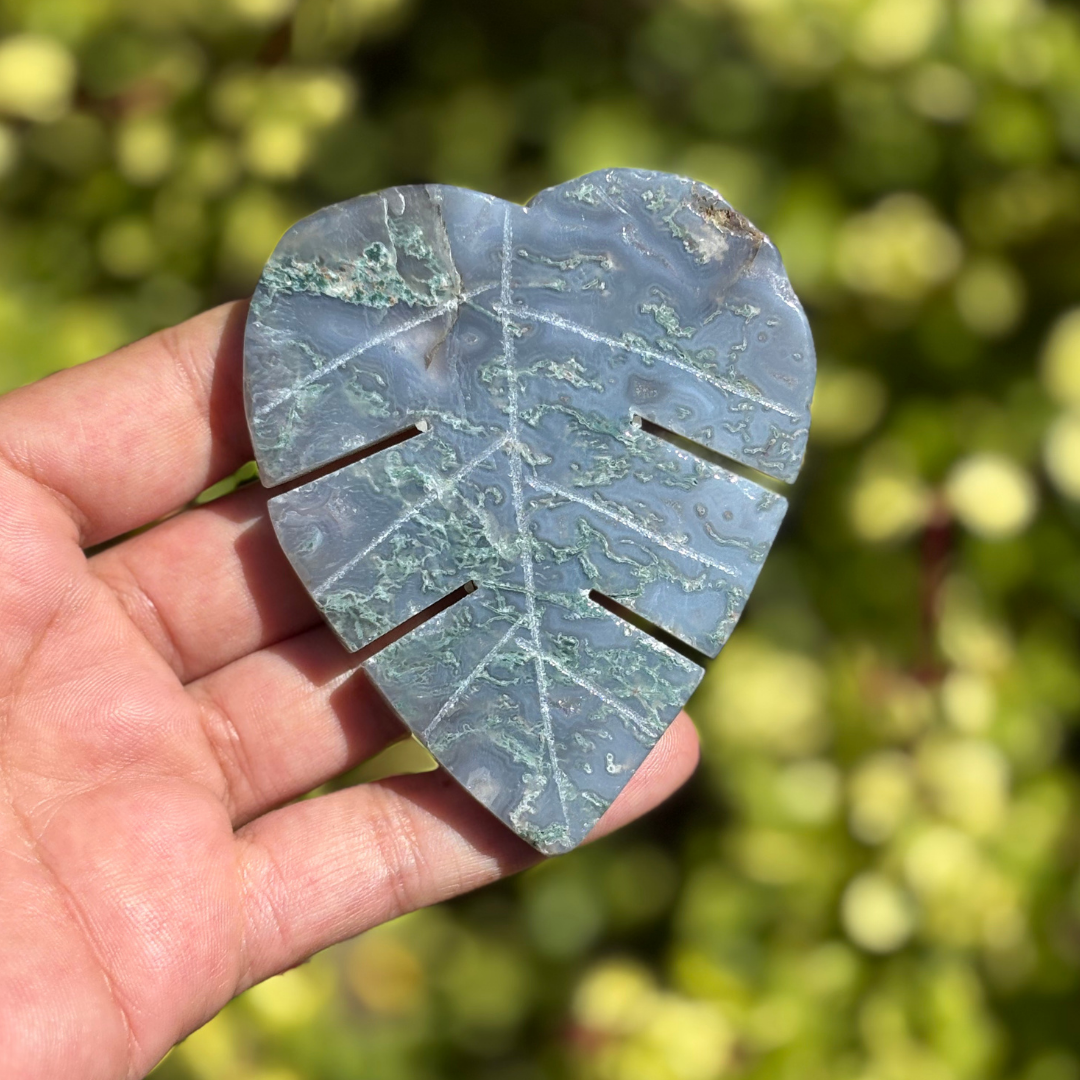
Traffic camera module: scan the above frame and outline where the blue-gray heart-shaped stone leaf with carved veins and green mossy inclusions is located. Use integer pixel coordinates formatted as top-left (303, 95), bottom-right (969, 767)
top-left (245, 170), bottom-right (814, 852)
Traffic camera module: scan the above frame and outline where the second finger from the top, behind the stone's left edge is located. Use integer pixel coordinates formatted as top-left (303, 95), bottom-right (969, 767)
top-left (90, 485), bottom-right (322, 683)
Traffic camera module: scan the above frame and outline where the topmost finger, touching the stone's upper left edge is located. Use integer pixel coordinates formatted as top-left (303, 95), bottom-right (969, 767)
top-left (0, 302), bottom-right (253, 546)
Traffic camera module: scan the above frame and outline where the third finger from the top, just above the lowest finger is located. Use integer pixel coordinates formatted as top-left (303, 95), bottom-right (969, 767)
top-left (188, 626), bottom-right (408, 825)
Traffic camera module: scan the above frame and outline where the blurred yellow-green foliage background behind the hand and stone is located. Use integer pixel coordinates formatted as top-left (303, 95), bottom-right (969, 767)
top-left (0, 0), bottom-right (1080, 1080)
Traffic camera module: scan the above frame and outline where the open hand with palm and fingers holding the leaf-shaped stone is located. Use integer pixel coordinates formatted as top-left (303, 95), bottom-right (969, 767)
top-left (0, 303), bottom-right (698, 1080)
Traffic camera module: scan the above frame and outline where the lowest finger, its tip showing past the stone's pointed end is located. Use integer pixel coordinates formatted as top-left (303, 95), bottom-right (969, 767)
top-left (237, 713), bottom-right (698, 985)
